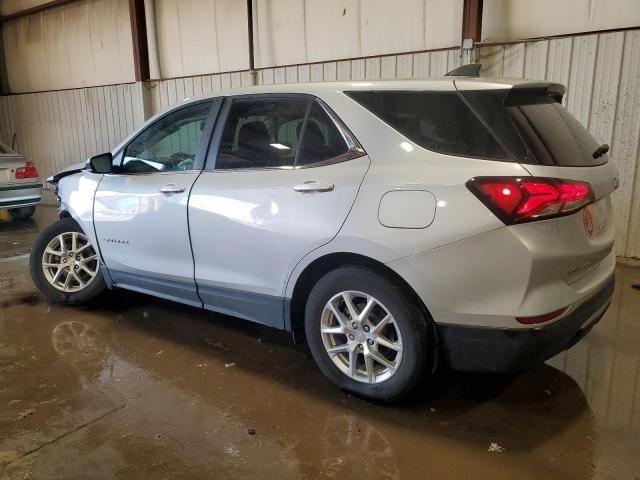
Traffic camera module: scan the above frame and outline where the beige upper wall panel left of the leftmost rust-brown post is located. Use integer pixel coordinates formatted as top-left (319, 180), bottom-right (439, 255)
top-left (2, 0), bottom-right (135, 93)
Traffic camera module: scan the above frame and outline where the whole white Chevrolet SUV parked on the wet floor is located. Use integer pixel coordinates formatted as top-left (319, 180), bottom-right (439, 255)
top-left (31, 77), bottom-right (617, 402)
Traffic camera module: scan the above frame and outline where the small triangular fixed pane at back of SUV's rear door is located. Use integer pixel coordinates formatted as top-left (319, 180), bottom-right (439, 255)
top-left (298, 102), bottom-right (349, 165)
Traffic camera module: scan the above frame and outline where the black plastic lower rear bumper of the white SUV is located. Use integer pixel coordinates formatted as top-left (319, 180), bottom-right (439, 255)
top-left (438, 276), bottom-right (615, 372)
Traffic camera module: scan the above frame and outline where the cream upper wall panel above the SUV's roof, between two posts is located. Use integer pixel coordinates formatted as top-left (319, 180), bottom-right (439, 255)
top-left (254, 0), bottom-right (463, 67)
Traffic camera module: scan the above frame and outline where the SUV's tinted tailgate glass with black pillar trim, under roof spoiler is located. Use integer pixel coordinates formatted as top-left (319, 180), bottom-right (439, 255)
top-left (460, 87), bottom-right (607, 167)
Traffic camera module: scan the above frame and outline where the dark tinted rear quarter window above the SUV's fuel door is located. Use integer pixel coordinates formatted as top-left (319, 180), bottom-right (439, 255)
top-left (345, 90), bottom-right (512, 161)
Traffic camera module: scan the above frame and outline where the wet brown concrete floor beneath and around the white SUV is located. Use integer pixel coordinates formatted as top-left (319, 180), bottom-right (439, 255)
top-left (0, 200), bottom-right (640, 480)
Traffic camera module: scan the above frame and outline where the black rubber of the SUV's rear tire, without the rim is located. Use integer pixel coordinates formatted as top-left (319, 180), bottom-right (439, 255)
top-left (305, 266), bottom-right (438, 403)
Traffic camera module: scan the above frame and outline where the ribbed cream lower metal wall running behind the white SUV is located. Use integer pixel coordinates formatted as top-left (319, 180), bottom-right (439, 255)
top-left (0, 29), bottom-right (640, 257)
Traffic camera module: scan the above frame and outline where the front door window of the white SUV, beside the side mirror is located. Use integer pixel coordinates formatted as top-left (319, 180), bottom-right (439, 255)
top-left (121, 102), bottom-right (211, 173)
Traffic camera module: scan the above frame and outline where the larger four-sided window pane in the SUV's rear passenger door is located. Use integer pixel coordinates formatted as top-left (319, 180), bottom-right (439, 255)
top-left (216, 98), bottom-right (309, 170)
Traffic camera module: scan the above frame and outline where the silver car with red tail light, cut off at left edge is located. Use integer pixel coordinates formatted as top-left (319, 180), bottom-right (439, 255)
top-left (0, 143), bottom-right (42, 220)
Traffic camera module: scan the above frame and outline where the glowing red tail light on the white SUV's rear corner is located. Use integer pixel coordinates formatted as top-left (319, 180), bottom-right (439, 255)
top-left (467, 177), bottom-right (594, 225)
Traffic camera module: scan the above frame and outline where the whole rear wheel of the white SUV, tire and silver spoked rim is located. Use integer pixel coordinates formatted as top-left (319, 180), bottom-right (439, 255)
top-left (305, 266), bottom-right (438, 403)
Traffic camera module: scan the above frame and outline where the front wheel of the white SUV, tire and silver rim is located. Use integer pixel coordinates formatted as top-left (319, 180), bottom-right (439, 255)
top-left (29, 218), bottom-right (106, 305)
